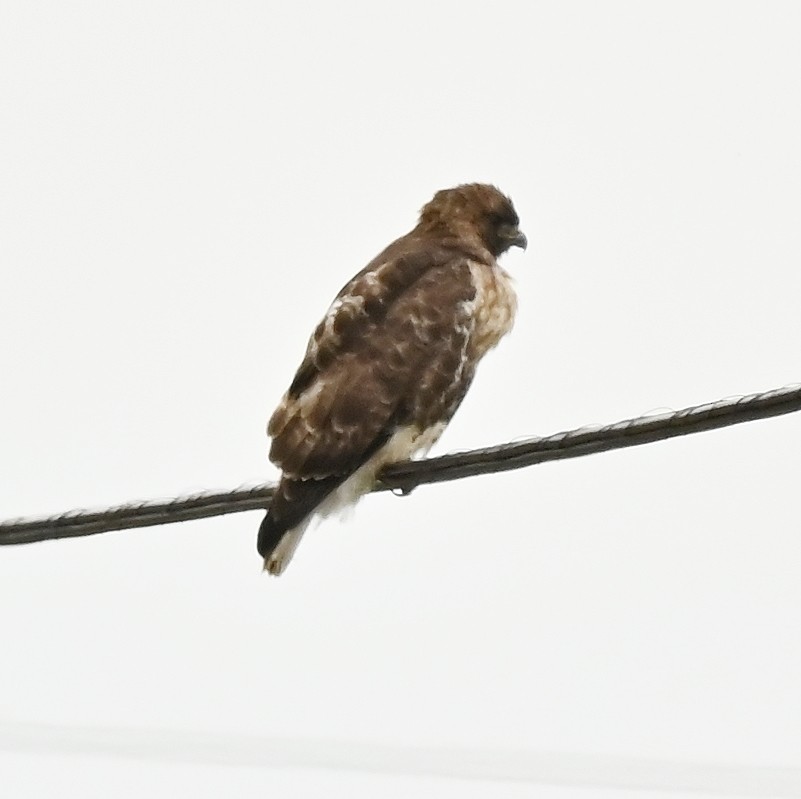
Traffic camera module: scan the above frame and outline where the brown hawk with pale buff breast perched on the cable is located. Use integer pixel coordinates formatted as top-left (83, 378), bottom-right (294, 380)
top-left (258, 183), bottom-right (526, 575)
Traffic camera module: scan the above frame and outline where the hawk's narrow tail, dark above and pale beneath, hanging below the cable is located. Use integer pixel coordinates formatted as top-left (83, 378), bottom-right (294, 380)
top-left (257, 477), bottom-right (342, 576)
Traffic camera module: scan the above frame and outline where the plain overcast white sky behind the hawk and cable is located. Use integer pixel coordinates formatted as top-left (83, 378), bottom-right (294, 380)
top-left (0, 0), bottom-right (801, 797)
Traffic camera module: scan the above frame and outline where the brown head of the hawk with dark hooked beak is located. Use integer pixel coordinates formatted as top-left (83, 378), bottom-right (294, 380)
top-left (420, 183), bottom-right (528, 258)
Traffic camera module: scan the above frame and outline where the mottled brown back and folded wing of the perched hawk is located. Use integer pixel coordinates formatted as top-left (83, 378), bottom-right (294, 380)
top-left (268, 237), bottom-right (475, 480)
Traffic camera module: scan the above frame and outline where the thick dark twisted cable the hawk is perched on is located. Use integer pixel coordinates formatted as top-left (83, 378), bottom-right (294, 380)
top-left (0, 384), bottom-right (801, 545)
